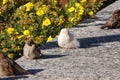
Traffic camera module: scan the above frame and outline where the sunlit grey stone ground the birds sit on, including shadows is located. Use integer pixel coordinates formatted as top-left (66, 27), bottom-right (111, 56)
top-left (0, 0), bottom-right (120, 80)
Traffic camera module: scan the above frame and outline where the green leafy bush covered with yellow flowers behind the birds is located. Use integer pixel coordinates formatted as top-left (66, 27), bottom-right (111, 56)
top-left (0, 0), bottom-right (104, 59)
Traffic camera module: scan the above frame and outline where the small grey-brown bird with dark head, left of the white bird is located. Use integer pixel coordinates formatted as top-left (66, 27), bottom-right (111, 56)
top-left (23, 39), bottom-right (42, 59)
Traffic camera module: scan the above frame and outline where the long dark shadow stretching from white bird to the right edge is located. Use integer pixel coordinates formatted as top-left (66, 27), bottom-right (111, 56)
top-left (78, 35), bottom-right (120, 48)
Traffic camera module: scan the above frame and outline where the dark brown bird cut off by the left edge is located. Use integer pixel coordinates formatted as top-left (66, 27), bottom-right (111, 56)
top-left (0, 52), bottom-right (31, 76)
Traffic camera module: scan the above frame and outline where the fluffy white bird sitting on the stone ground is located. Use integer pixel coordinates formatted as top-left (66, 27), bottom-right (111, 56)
top-left (58, 28), bottom-right (80, 49)
